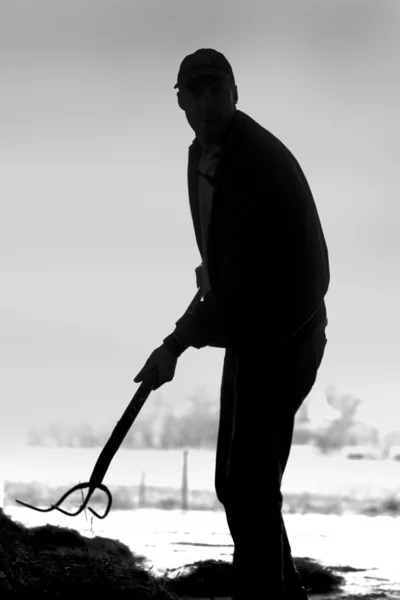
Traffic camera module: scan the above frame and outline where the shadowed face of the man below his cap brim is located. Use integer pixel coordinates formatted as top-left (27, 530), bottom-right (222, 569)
top-left (180, 75), bottom-right (236, 145)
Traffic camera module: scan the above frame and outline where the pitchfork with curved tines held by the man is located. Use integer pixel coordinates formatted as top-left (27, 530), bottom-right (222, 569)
top-left (16, 289), bottom-right (201, 519)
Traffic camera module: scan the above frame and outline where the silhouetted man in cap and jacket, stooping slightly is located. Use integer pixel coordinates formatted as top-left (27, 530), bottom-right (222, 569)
top-left (134, 48), bottom-right (330, 600)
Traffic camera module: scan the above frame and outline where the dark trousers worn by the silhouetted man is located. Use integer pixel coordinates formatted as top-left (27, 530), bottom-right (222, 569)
top-left (215, 329), bottom-right (327, 600)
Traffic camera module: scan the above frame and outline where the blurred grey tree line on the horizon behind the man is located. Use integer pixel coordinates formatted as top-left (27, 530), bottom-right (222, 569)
top-left (26, 387), bottom-right (400, 455)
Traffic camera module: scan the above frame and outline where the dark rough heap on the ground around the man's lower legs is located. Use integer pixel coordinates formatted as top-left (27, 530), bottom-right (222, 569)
top-left (0, 509), bottom-right (343, 600)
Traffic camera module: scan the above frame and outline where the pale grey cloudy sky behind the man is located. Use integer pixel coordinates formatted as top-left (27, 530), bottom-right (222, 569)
top-left (0, 0), bottom-right (400, 450)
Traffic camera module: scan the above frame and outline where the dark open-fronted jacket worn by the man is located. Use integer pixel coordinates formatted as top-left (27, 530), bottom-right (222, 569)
top-left (164, 109), bottom-right (330, 355)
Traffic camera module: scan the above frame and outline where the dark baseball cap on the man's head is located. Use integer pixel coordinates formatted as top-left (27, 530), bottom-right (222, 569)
top-left (174, 48), bottom-right (235, 89)
